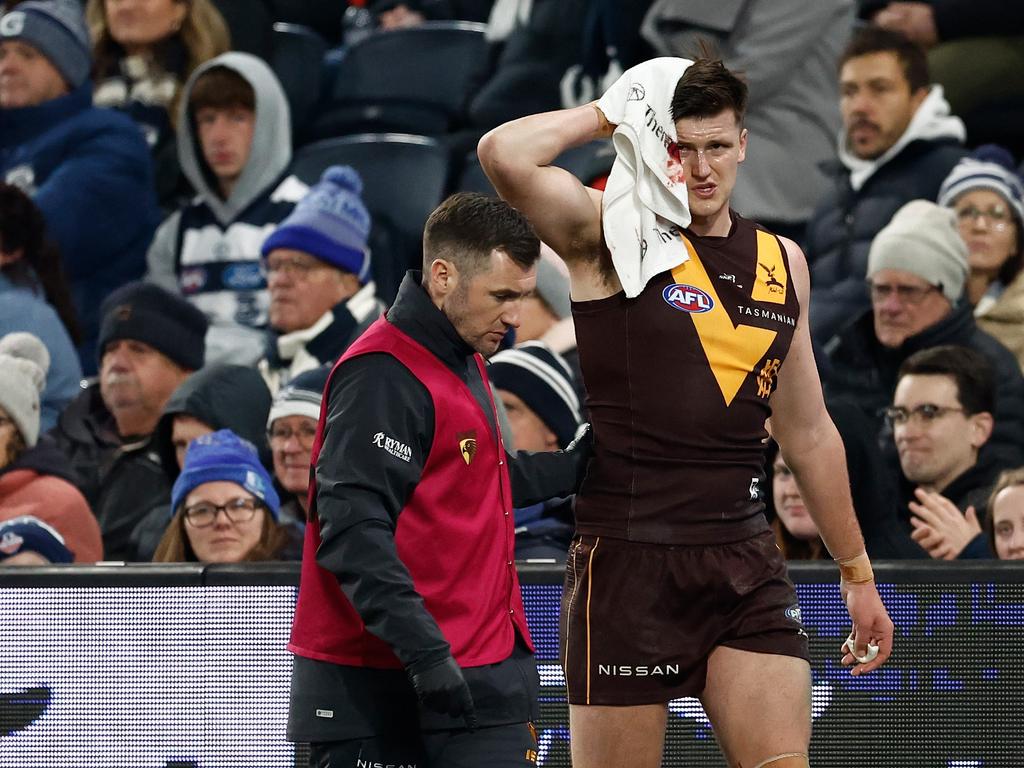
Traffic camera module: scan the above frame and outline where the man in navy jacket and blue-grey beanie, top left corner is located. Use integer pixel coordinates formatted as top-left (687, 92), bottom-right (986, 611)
top-left (0, 0), bottom-right (160, 374)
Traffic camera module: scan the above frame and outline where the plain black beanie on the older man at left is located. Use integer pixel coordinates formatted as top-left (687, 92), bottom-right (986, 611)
top-left (96, 283), bottom-right (209, 371)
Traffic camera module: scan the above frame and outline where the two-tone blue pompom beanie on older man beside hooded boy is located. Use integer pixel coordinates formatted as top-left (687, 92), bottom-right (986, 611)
top-left (262, 165), bottom-right (370, 285)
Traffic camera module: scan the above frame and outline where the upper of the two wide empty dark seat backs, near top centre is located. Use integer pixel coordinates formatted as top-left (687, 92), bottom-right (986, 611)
top-left (313, 22), bottom-right (490, 136)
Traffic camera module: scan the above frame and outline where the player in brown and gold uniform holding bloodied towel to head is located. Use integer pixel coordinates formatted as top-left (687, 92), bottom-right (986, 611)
top-left (478, 58), bottom-right (892, 768)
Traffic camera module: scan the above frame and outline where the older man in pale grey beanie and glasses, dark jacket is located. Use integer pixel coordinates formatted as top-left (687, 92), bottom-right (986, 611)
top-left (823, 200), bottom-right (1024, 469)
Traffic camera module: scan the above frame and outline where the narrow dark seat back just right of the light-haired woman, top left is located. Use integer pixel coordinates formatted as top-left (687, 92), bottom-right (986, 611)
top-left (270, 22), bottom-right (327, 135)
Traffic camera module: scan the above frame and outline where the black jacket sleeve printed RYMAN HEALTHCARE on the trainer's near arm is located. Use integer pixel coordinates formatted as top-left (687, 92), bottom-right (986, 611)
top-left (316, 354), bottom-right (450, 667)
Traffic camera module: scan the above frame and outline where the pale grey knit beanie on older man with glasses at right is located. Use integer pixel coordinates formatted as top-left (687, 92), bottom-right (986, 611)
top-left (867, 200), bottom-right (968, 304)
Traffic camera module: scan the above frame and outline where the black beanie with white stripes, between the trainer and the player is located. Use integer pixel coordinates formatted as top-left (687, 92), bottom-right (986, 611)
top-left (487, 341), bottom-right (581, 447)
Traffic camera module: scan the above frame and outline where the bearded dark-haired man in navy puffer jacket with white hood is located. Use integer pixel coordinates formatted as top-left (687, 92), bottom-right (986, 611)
top-left (806, 28), bottom-right (967, 343)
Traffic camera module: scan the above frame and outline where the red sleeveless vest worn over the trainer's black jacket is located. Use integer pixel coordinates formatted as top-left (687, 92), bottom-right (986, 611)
top-left (288, 317), bottom-right (529, 669)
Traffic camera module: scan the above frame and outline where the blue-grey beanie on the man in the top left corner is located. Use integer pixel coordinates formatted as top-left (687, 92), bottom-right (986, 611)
top-left (0, 0), bottom-right (92, 88)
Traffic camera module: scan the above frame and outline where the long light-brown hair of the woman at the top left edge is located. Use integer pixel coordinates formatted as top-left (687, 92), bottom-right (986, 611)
top-left (85, 0), bottom-right (231, 82)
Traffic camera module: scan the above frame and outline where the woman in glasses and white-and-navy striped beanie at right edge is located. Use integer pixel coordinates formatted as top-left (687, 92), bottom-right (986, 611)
top-left (939, 144), bottom-right (1024, 366)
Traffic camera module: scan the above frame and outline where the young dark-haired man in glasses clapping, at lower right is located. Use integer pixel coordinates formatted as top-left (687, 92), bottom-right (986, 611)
top-left (886, 346), bottom-right (1007, 560)
